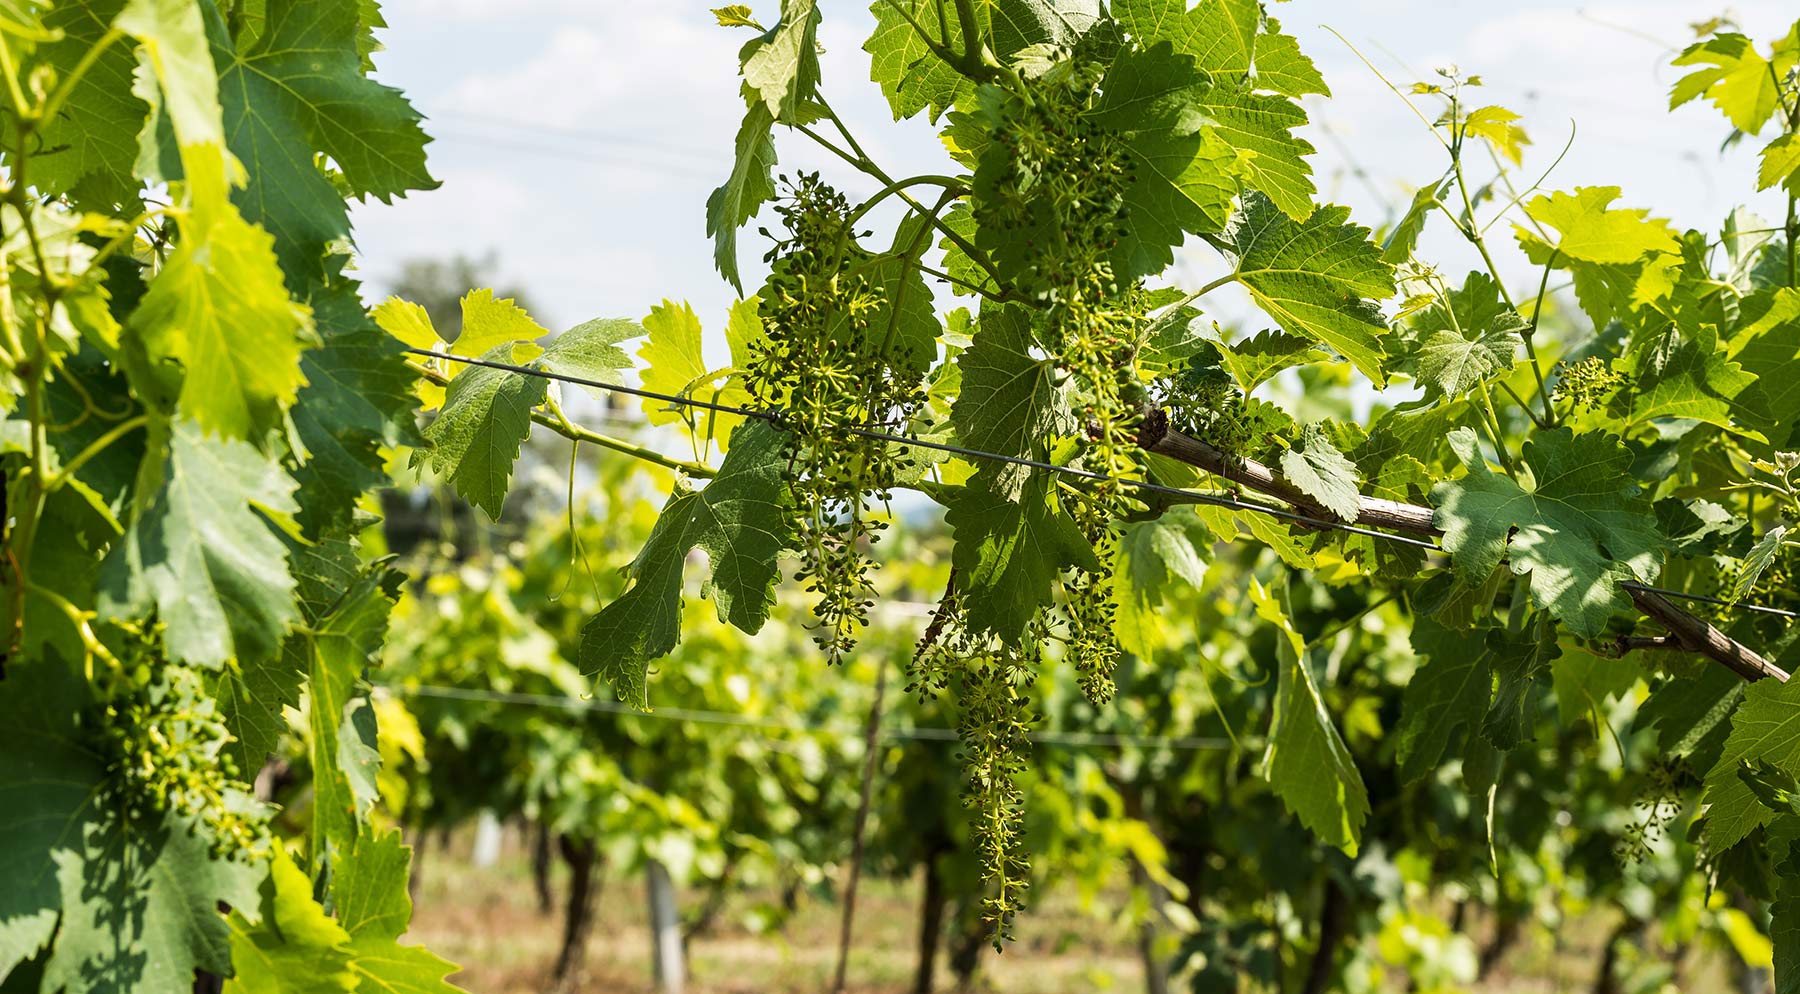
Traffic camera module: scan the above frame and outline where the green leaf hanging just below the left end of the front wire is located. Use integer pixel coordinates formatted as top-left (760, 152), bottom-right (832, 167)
top-left (412, 344), bottom-right (549, 520)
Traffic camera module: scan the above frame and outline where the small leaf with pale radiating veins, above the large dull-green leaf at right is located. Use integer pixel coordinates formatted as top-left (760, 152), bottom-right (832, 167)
top-left (1413, 272), bottom-right (1528, 398)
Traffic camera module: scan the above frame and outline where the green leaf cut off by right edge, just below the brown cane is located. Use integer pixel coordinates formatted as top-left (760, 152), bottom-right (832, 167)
top-left (1705, 681), bottom-right (1800, 852)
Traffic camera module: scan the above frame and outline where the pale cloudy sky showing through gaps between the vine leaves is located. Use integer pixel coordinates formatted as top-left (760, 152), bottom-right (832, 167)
top-left (353, 0), bottom-right (1795, 358)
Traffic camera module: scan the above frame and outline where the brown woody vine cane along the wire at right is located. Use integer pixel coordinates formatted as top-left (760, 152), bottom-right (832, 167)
top-left (1138, 411), bottom-right (1787, 682)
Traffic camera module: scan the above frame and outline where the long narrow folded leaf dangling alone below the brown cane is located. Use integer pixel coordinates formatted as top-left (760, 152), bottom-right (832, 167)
top-left (1251, 580), bottom-right (1370, 857)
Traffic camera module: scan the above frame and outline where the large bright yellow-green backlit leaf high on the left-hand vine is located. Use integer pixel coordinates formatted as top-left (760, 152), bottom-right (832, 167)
top-left (130, 198), bottom-right (317, 439)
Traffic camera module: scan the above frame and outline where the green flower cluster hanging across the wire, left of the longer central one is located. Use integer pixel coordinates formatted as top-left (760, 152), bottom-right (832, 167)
top-left (745, 173), bottom-right (923, 663)
